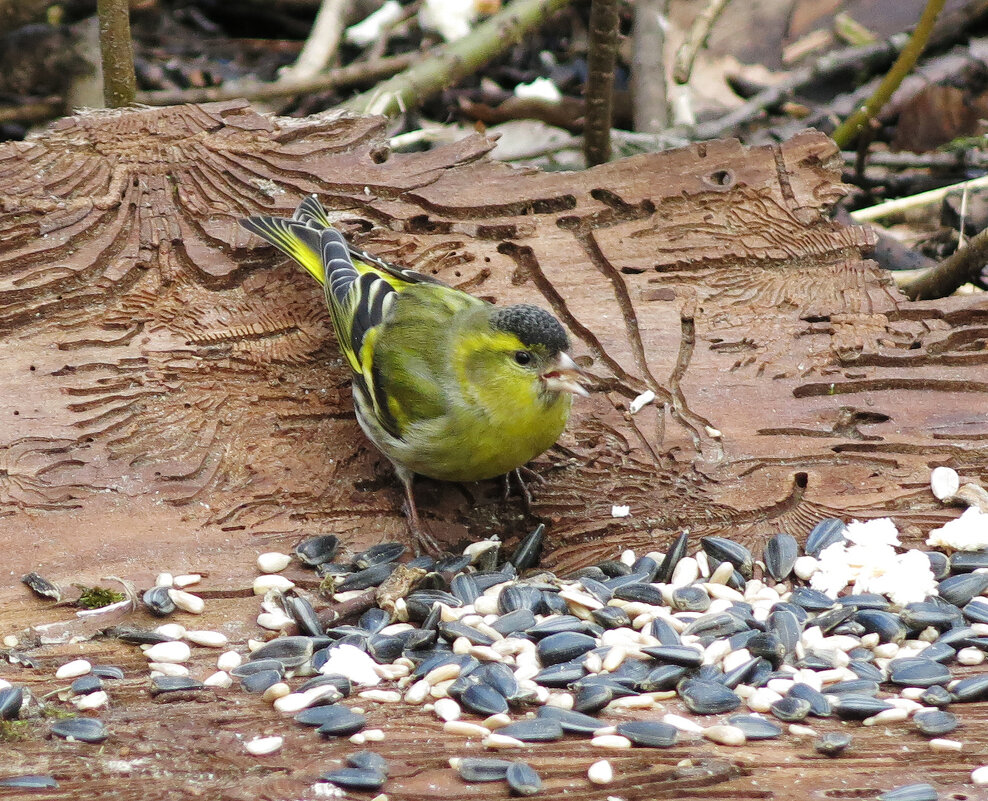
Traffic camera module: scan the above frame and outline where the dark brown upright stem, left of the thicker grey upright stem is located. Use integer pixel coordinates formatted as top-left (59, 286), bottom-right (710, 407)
top-left (583, 0), bottom-right (618, 167)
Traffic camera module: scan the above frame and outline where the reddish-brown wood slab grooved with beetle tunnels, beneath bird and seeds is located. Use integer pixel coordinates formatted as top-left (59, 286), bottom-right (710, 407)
top-left (0, 102), bottom-right (988, 801)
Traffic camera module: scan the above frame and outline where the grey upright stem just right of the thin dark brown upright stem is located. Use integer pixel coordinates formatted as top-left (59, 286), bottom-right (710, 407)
top-left (631, 0), bottom-right (672, 133)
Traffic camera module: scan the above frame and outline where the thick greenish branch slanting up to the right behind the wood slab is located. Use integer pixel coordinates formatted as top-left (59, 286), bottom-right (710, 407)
top-left (342, 0), bottom-right (569, 116)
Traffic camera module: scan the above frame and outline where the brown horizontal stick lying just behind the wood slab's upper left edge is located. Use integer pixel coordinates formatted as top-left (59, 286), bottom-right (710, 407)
top-left (137, 53), bottom-right (412, 106)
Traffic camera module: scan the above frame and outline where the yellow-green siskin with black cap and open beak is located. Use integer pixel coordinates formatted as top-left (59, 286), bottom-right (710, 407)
top-left (240, 196), bottom-right (587, 551)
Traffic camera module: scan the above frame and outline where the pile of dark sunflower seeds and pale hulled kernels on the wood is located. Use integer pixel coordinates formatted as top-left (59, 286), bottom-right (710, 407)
top-left (0, 466), bottom-right (988, 801)
